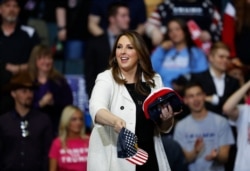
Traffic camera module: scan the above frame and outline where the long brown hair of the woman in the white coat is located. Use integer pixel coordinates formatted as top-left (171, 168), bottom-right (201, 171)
top-left (109, 31), bottom-right (155, 94)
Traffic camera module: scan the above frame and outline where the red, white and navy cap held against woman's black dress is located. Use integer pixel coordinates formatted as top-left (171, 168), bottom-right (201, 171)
top-left (142, 87), bottom-right (183, 121)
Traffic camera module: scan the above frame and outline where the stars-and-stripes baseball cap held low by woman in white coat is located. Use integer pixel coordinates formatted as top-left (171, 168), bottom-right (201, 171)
top-left (117, 128), bottom-right (148, 165)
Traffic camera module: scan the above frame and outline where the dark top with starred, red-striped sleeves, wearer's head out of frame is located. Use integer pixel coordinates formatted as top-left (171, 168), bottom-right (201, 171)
top-left (145, 0), bottom-right (222, 41)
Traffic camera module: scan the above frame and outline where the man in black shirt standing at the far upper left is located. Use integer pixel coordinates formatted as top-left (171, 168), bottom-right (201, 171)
top-left (0, 0), bottom-right (39, 114)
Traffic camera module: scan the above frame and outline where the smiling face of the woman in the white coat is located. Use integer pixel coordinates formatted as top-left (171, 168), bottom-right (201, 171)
top-left (116, 36), bottom-right (139, 72)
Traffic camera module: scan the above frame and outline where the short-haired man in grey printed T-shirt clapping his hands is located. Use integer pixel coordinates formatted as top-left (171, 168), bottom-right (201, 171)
top-left (174, 82), bottom-right (234, 171)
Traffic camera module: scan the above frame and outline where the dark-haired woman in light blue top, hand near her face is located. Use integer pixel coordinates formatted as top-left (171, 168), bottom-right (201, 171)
top-left (151, 18), bottom-right (208, 92)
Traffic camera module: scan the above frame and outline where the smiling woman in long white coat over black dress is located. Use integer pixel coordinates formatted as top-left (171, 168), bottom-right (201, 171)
top-left (87, 31), bottom-right (182, 171)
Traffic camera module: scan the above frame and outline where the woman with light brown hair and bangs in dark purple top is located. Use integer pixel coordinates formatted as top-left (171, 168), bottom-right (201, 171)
top-left (28, 45), bottom-right (73, 133)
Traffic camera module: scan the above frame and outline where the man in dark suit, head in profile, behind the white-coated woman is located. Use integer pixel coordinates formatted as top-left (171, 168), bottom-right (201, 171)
top-left (84, 2), bottom-right (130, 96)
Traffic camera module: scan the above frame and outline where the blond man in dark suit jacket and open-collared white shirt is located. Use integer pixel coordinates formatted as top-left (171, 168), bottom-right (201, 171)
top-left (191, 42), bottom-right (239, 114)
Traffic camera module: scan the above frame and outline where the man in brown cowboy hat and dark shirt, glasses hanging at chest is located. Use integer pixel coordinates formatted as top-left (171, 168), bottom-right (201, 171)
top-left (0, 72), bottom-right (53, 171)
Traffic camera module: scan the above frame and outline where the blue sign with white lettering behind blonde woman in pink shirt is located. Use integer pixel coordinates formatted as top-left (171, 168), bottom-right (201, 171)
top-left (65, 74), bottom-right (92, 129)
